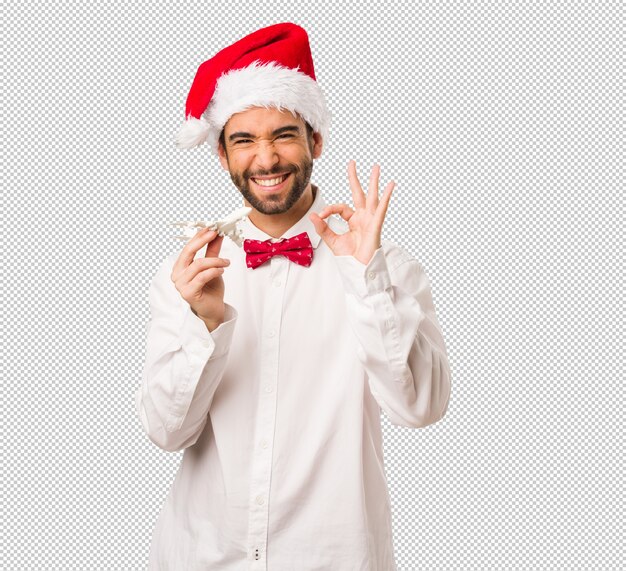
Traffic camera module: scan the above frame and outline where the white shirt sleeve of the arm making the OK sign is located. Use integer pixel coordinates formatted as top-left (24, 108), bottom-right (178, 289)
top-left (335, 243), bottom-right (450, 428)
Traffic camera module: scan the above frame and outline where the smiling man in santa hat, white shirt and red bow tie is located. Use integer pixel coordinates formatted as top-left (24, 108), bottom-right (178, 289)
top-left (136, 24), bottom-right (450, 571)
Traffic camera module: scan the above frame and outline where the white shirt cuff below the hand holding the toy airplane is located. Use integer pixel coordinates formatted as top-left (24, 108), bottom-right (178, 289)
top-left (180, 303), bottom-right (239, 359)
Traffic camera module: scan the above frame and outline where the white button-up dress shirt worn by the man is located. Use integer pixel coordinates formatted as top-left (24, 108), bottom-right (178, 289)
top-left (135, 185), bottom-right (450, 571)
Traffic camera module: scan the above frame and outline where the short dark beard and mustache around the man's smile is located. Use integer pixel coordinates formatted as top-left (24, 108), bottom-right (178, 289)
top-left (229, 153), bottom-right (313, 214)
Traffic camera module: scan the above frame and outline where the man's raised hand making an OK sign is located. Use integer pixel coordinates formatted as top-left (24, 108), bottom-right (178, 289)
top-left (309, 160), bottom-right (396, 265)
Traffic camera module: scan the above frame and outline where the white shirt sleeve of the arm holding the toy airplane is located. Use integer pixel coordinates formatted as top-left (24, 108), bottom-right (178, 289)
top-left (135, 256), bottom-right (238, 452)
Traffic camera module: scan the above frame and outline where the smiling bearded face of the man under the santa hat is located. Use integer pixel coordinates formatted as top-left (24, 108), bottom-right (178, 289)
top-left (218, 107), bottom-right (322, 214)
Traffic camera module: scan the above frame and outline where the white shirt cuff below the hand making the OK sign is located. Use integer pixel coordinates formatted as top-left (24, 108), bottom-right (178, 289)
top-left (335, 246), bottom-right (391, 298)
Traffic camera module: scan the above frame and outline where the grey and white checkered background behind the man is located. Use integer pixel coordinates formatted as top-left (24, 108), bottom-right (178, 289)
top-left (0, 1), bottom-right (625, 571)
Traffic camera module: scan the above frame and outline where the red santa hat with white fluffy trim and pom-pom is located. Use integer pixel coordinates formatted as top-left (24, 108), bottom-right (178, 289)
top-left (176, 22), bottom-right (331, 154)
